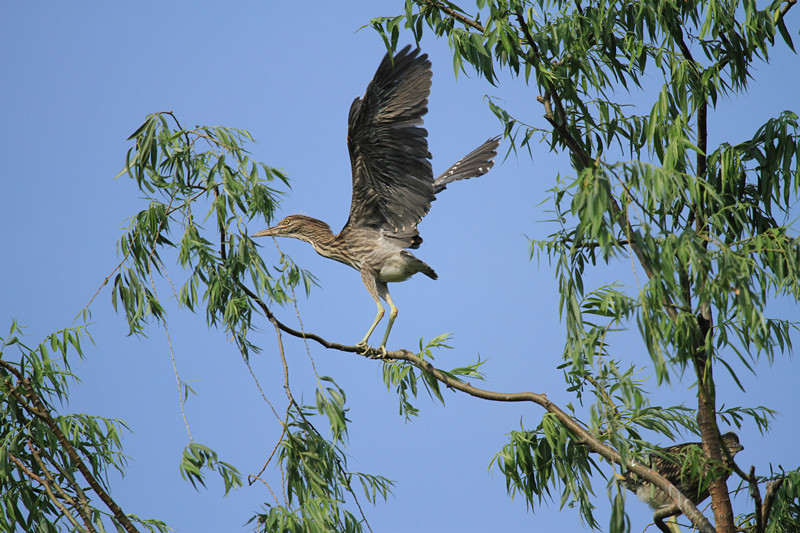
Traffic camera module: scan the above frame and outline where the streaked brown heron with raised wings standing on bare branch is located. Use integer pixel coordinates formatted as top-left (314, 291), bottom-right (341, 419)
top-left (252, 46), bottom-right (500, 356)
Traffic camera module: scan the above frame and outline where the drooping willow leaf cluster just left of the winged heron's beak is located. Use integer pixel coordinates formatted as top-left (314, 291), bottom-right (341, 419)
top-left (112, 113), bottom-right (314, 357)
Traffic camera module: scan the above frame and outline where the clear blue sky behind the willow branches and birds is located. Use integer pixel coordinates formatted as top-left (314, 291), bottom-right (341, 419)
top-left (0, 1), bottom-right (800, 532)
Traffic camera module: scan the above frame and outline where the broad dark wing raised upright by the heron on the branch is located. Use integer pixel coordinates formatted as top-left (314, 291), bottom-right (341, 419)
top-left (342, 46), bottom-right (434, 239)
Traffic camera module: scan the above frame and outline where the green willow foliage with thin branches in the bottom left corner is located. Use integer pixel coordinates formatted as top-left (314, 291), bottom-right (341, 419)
top-left (0, 323), bottom-right (167, 531)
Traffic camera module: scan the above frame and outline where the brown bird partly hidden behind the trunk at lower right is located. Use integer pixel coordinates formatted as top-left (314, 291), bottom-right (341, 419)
top-left (626, 431), bottom-right (744, 510)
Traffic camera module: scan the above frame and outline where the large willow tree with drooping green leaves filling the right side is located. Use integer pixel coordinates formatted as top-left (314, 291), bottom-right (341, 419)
top-left (372, 0), bottom-right (800, 531)
